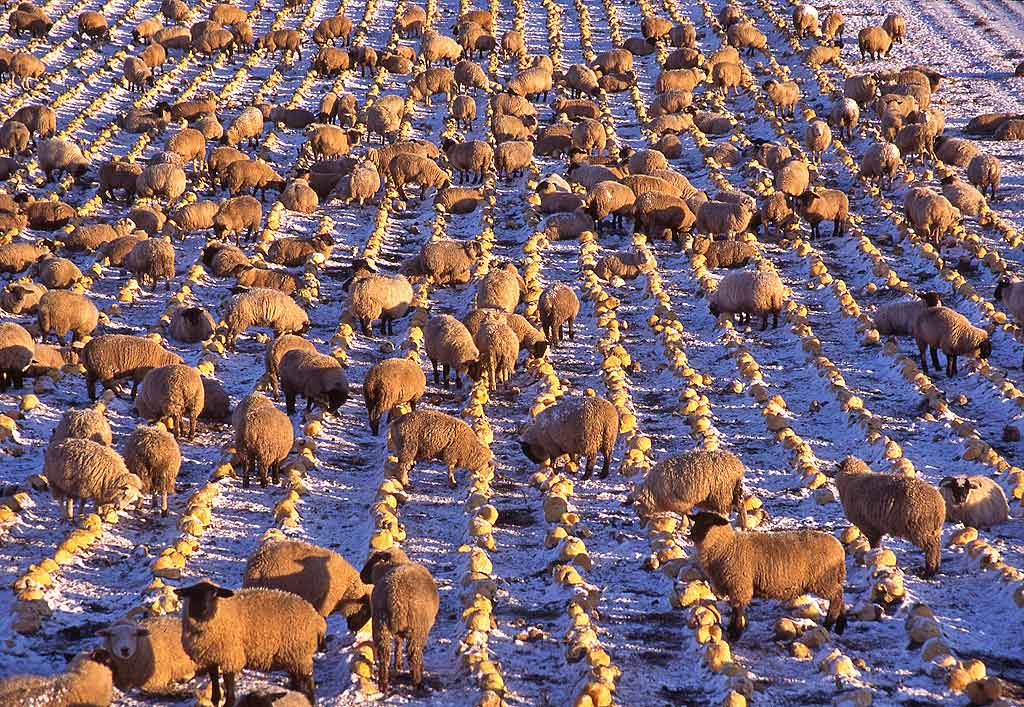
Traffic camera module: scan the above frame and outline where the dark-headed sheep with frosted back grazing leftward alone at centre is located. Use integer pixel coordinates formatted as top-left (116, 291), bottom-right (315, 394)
top-left (519, 397), bottom-right (618, 479)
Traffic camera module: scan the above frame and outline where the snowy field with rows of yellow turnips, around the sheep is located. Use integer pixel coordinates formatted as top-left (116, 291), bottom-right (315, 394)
top-left (0, 0), bottom-right (1024, 707)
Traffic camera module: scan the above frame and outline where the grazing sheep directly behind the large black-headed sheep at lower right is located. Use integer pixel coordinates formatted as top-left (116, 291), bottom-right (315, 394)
top-left (633, 449), bottom-right (743, 521)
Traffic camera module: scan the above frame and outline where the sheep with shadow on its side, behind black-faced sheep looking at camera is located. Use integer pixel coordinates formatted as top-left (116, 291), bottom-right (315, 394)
top-left (242, 540), bottom-right (371, 631)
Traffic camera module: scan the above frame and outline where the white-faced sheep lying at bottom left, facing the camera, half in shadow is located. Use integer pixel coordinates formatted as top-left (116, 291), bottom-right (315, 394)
top-left (96, 616), bottom-right (197, 695)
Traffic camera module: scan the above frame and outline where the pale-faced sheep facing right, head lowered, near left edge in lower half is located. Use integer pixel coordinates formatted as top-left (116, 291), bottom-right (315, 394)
top-left (43, 439), bottom-right (142, 521)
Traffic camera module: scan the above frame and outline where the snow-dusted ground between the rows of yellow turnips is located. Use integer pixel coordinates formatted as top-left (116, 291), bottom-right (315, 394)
top-left (0, 0), bottom-right (1024, 707)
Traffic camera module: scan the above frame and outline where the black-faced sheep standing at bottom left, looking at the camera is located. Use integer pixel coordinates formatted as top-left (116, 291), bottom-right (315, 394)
top-left (174, 580), bottom-right (327, 705)
